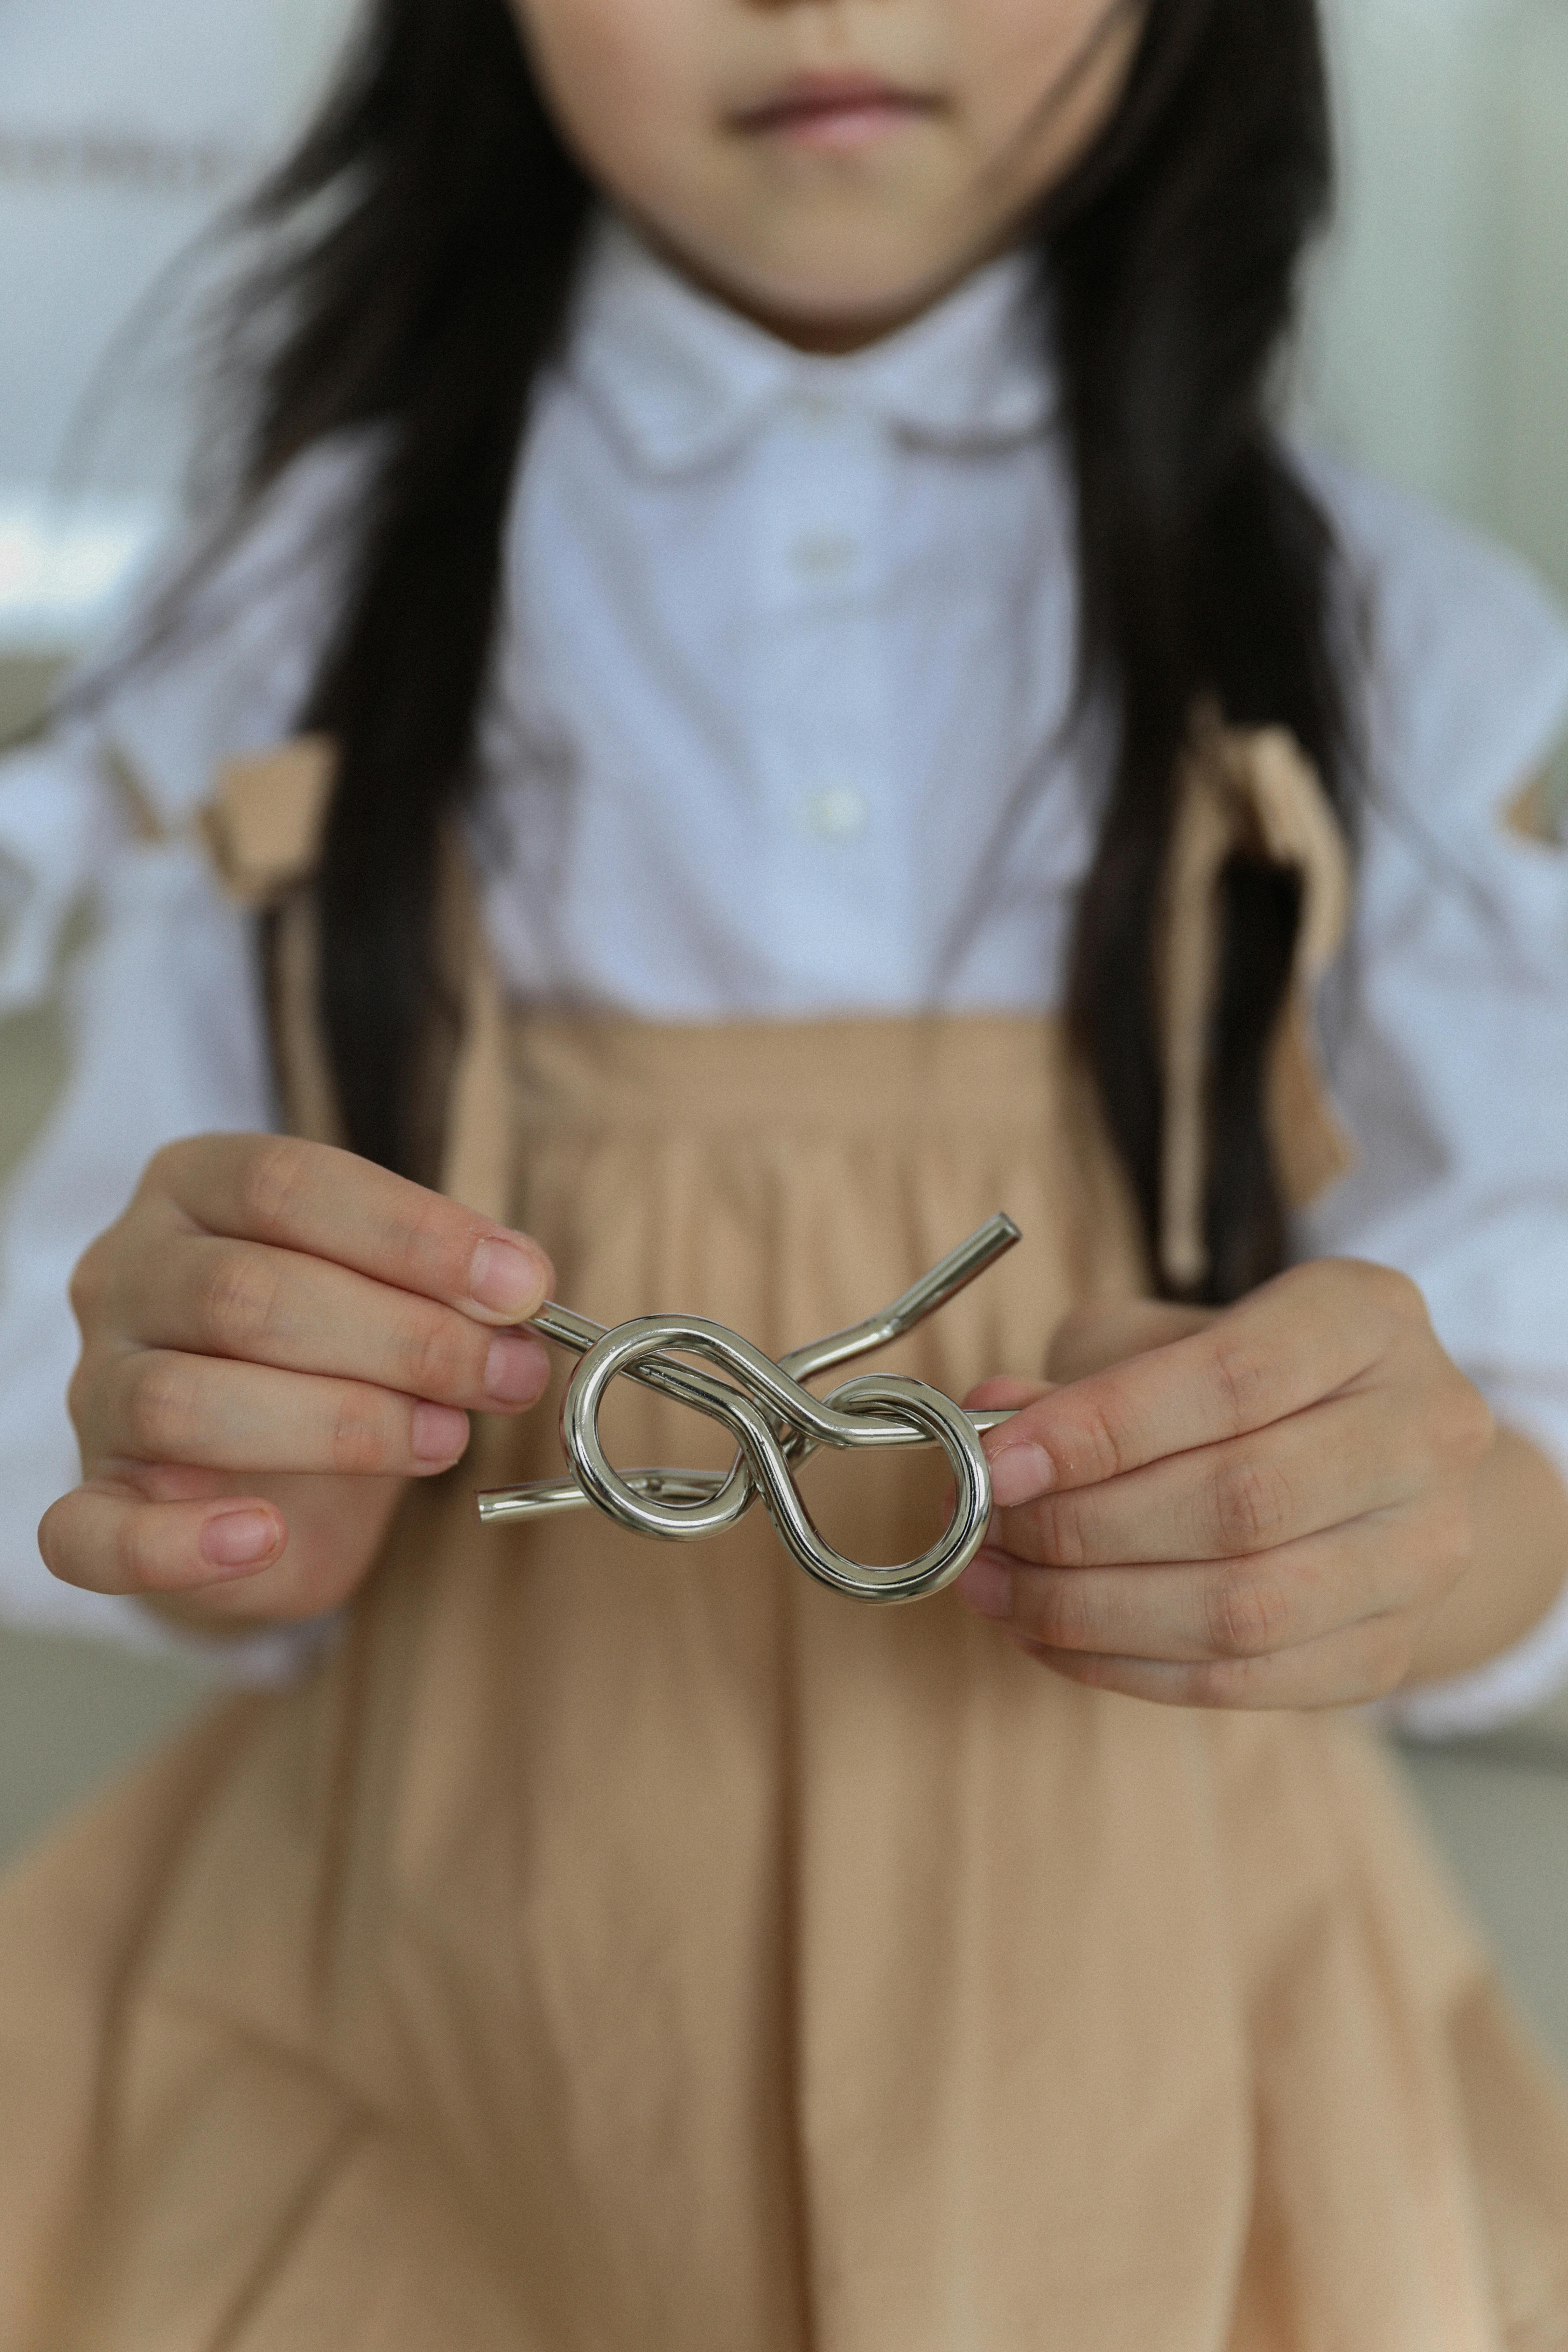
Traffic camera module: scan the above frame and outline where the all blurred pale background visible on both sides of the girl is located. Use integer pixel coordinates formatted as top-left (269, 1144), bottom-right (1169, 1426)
top-left (0, 0), bottom-right (1568, 2058)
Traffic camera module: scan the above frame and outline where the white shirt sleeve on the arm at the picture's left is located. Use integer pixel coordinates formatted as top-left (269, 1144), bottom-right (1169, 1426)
top-left (0, 442), bottom-right (373, 1682)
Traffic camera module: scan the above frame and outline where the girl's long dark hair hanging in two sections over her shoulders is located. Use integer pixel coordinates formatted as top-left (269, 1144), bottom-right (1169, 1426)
top-left (221, 0), bottom-right (1347, 1298)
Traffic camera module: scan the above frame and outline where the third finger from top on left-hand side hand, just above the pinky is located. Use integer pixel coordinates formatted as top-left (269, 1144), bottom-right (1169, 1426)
top-left (96, 1348), bottom-right (468, 1477)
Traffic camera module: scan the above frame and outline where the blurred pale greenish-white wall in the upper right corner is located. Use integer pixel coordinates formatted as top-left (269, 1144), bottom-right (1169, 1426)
top-left (1302, 0), bottom-right (1568, 593)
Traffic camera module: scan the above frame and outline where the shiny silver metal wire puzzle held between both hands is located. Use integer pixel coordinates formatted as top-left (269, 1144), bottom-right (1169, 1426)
top-left (479, 1216), bottom-right (1020, 1602)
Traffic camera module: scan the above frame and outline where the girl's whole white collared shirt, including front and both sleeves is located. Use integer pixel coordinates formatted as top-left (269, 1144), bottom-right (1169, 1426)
top-left (0, 228), bottom-right (1568, 1731)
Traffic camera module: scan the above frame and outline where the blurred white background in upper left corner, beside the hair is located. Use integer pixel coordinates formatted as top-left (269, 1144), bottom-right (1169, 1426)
top-left (0, 0), bottom-right (348, 682)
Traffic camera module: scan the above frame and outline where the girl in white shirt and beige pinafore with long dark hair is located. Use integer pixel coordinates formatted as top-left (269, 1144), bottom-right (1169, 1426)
top-left (0, 0), bottom-right (1568, 2352)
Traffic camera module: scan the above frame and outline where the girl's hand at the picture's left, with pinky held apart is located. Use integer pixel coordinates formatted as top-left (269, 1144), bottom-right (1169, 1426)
top-left (37, 1136), bottom-right (555, 1625)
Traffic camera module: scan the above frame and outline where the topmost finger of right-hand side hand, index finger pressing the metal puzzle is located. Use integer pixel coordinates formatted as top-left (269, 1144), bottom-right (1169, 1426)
top-left (987, 1261), bottom-right (1424, 1503)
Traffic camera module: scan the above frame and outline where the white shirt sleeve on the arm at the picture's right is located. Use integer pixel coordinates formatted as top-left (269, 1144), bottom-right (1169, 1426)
top-left (1298, 458), bottom-right (1568, 1736)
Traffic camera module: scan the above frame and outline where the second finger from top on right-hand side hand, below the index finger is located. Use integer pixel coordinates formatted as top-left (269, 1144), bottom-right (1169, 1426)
top-left (994, 1395), bottom-right (1432, 1569)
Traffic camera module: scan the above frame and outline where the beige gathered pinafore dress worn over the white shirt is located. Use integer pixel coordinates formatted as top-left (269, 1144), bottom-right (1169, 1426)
top-left (0, 724), bottom-right (1568, 2352)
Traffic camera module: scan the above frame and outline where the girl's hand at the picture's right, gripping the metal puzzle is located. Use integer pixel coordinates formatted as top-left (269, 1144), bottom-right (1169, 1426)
top-left (959, 1258), bottom-right (1493, 1708)
